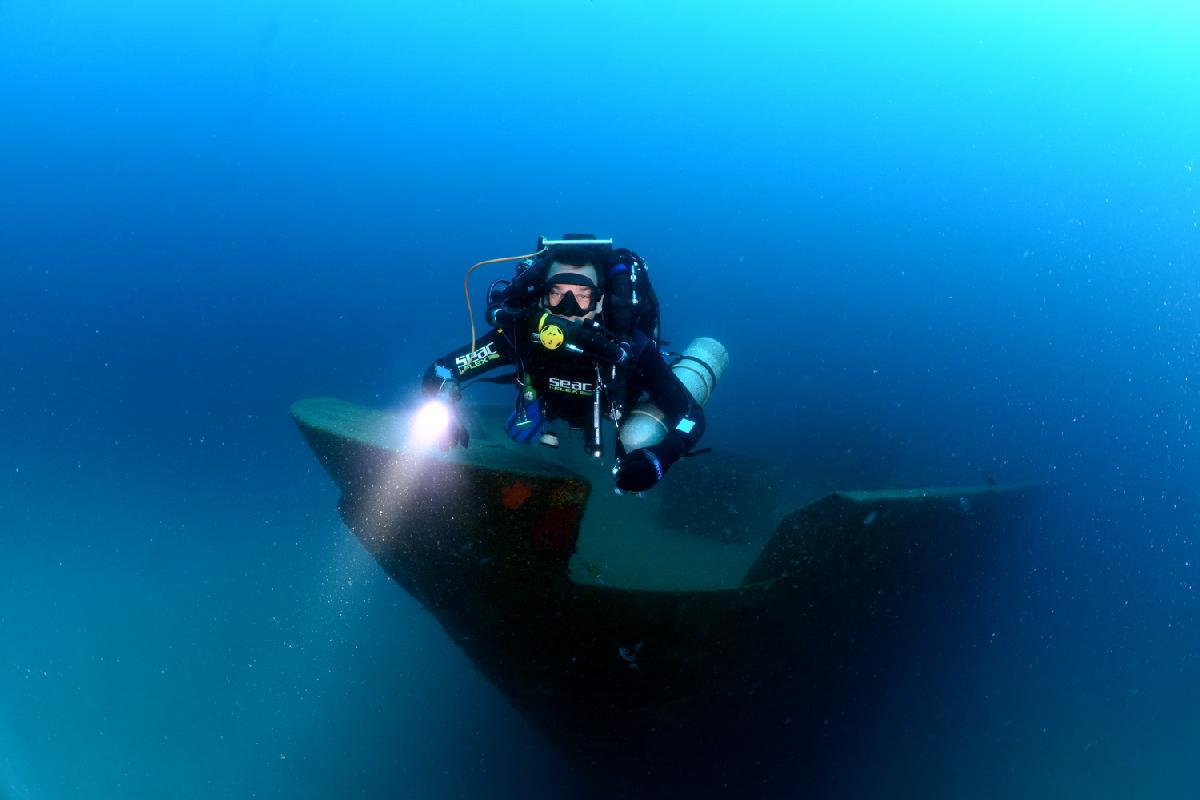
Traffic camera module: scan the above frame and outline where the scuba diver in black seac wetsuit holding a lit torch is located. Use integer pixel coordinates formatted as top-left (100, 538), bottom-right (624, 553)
top-left (421, 234), bottom-right (716, 493)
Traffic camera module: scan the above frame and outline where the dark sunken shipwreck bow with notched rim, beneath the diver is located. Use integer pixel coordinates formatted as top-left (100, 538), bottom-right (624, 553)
top-left (292, 399), bottom-right (1036, 796)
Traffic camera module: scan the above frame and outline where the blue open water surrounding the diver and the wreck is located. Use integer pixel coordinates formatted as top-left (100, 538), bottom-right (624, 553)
top-left (0, 0), bottom-right (1200, 800)
